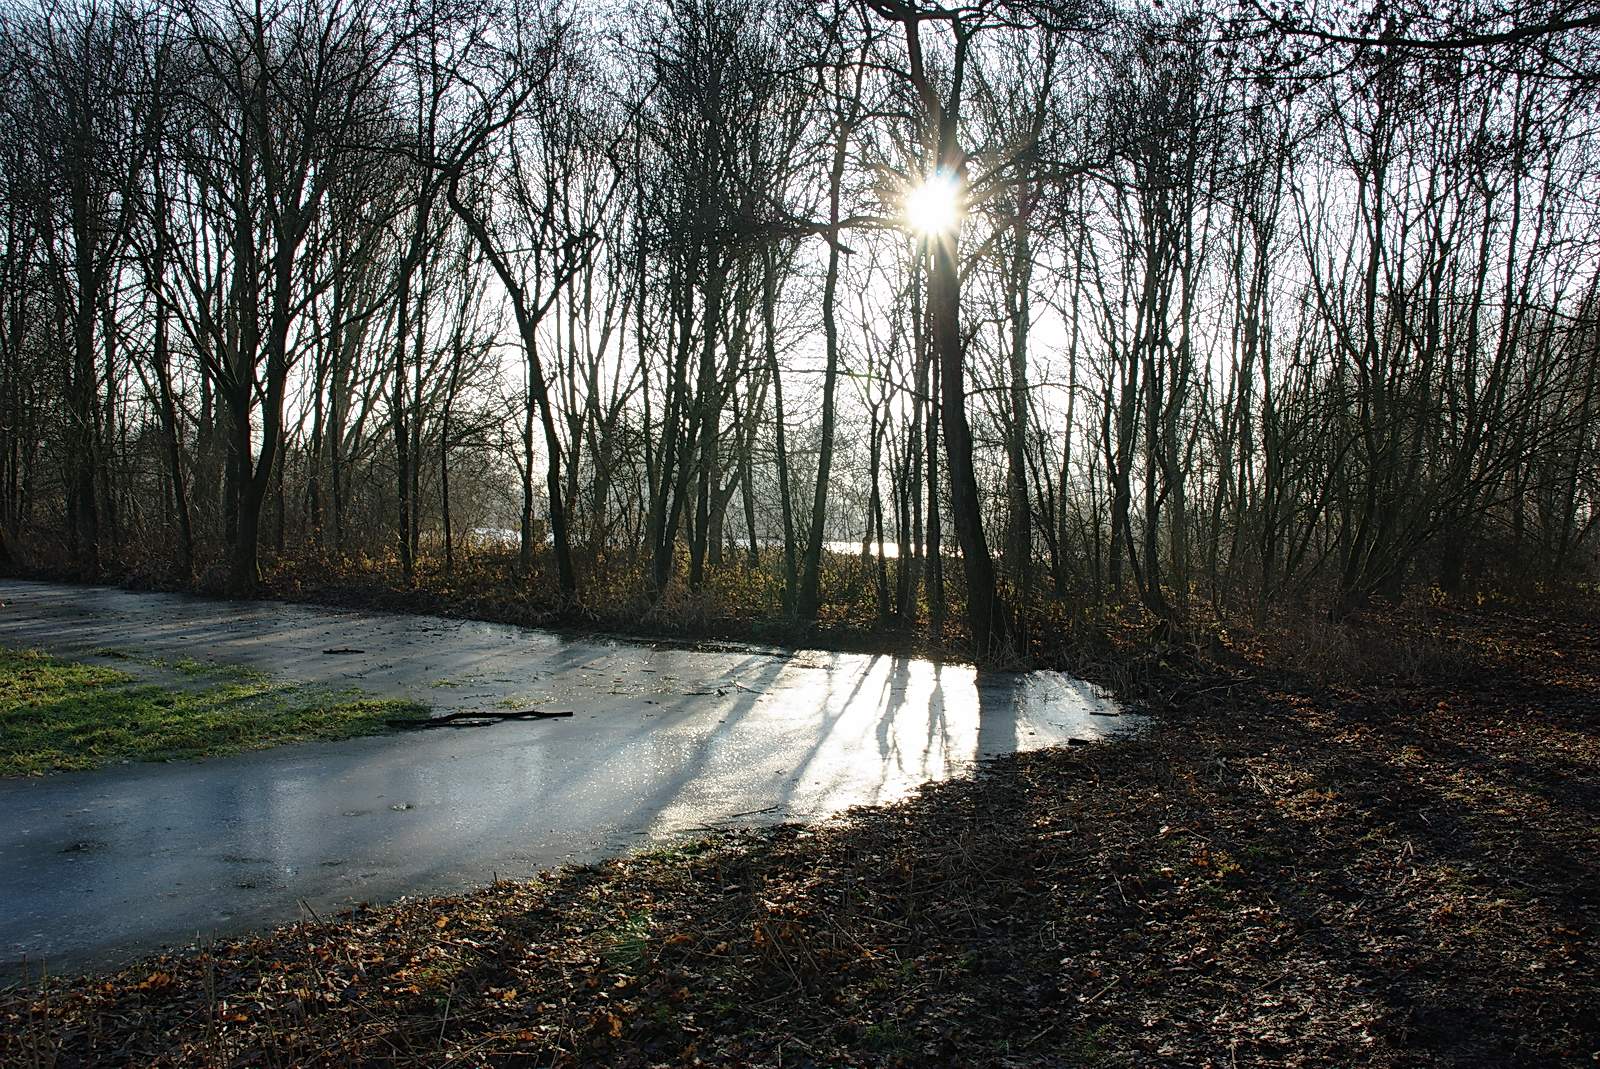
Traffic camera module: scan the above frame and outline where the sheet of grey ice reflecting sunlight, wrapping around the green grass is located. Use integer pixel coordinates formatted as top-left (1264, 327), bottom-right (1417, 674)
top-left (0, 581), bottom-right (1138, 970)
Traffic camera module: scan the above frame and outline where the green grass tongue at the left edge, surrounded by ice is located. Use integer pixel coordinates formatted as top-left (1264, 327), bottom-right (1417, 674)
top-left (0, 650), bottom-right (427, 776)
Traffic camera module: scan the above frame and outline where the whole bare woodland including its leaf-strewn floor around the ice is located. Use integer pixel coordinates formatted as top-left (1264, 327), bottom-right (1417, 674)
top-left (0, 0), bottom-right (1600, 1069)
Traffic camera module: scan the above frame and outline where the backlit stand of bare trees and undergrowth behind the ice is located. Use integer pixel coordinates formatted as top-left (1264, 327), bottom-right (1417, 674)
top-left (0, 0), bottom-right (1600, 664)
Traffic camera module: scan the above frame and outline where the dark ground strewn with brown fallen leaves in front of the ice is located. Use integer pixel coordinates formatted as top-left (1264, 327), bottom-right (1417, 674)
top-left (0, 598), bottom-right (1600, 1067)
